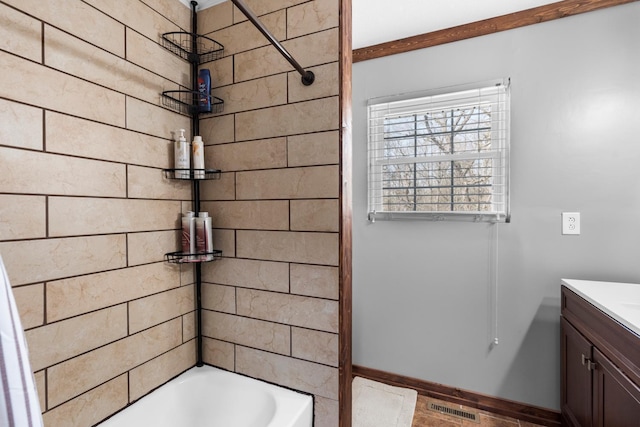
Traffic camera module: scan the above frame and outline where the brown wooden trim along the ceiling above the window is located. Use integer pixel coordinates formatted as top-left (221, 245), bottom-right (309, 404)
top-left (353, 0), bottom-right (638, 63)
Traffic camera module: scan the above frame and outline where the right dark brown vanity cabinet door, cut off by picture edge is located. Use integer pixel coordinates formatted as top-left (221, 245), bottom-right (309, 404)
top-left (593, 348), bottom-right (640, 427)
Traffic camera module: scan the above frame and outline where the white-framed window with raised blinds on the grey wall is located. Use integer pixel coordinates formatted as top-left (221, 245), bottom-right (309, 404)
top-left (368, 80), bottom-right (510, 222)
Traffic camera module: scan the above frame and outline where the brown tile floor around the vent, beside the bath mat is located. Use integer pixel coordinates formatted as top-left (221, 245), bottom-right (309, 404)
top-left (412, 395), bottom-right (540, 427)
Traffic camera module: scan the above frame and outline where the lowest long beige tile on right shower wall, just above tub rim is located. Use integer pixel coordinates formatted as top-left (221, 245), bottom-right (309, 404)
top-left (236, 346), bottom-right (338, 400)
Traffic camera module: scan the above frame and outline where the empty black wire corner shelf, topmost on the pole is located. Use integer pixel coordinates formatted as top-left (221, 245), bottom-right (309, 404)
top-left (162, 31), bottom-right (224, 64)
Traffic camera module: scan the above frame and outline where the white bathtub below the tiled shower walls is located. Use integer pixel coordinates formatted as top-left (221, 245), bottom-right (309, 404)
top-left (99, 365), bottom-right (313, 427)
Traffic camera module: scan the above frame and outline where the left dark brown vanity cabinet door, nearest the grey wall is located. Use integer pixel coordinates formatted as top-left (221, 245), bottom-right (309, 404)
top-left (560, 318), bottom-right (593, 427)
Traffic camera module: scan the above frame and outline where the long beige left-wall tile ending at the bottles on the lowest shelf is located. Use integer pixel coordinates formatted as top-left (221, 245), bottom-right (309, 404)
top-left (49, 197), bottom-right (180, 236)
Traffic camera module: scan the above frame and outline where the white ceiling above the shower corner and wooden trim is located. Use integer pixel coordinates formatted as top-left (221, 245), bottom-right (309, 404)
top-left (180, 0), bottom-right (558, 49)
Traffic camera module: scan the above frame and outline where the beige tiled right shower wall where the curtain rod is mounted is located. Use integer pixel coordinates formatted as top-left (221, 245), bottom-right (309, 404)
top-left (198, 0), bottom-right (340, 427)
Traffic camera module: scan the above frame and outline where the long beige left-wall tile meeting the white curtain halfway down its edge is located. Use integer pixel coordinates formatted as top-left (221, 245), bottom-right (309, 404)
top-left (25, 304), bottom-right (127, 371)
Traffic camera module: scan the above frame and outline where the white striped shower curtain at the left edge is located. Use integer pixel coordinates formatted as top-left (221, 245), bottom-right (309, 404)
top-left (0, 256), bottom-right (43, 427)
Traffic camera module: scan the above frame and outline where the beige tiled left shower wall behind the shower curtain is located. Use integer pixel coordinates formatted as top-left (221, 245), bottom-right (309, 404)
top-left (0, 0), bottom-right (195, 427)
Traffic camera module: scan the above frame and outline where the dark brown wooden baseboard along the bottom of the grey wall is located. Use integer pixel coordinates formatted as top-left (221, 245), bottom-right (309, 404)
top-left (352, 365), bottom-right (561, 427)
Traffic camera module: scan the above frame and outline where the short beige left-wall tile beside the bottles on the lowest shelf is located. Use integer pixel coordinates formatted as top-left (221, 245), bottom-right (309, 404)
top-left (127, 230), bottom-right (180, 270)
